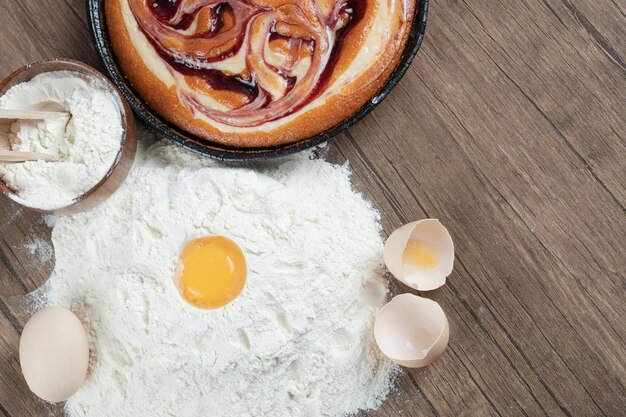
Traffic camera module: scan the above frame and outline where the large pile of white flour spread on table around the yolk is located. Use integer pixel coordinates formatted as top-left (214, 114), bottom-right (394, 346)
top-left (34, 142), bottom-right (395, 417)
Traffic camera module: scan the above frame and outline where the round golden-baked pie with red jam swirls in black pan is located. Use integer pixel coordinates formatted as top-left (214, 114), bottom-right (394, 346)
top-left (105, 0), bottom-right (416, 148)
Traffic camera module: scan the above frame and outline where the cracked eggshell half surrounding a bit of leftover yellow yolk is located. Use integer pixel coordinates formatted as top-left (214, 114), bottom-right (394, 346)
top-left (383, 219), bottom-right (454, 291)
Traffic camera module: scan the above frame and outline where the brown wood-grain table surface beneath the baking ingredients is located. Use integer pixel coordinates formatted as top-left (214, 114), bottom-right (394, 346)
top-left (0, 0), bottom-right (626, 417)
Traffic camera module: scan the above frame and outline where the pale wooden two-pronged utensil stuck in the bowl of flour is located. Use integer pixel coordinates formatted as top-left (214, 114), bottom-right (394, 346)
top-left (0, 109), bottom-right (69, 163)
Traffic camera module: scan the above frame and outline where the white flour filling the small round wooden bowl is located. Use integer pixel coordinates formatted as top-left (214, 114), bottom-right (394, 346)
top-left (0, 71), bottom-right (123, 209)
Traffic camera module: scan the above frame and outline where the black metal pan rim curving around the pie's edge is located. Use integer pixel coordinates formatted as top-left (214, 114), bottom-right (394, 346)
top-left (86, 0), bottom-right (430, 162)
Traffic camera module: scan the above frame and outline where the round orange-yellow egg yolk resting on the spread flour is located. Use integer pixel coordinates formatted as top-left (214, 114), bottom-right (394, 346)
top-left (175, 236), bottom-right (247, 310)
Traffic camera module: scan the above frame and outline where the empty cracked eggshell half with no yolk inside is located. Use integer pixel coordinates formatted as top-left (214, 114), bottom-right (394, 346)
top-left (374, 294), bottom-right (450, 368)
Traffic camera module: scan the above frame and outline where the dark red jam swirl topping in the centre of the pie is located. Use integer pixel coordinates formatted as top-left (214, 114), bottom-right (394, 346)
top-left (128, 0), bottom-right (366, 127)
